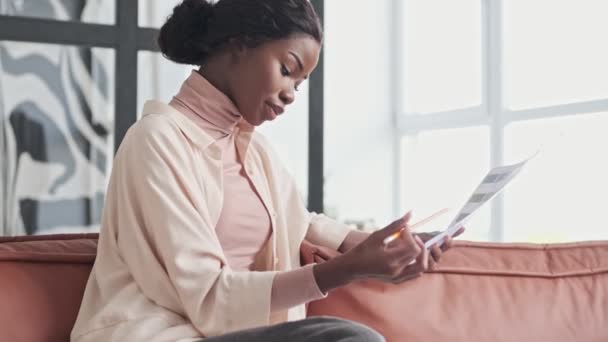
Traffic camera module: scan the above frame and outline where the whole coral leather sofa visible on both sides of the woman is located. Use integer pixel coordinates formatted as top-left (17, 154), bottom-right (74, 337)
top-left (0, 234), bottom-right (608, 342)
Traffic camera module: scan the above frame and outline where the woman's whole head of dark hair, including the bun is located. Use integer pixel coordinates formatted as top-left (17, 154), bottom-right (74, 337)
top-left (158, 0), bottom-right (323, 65)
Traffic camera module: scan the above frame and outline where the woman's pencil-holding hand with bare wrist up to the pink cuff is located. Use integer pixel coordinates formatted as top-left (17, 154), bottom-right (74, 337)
top-left (313, 213), bottom-right (429, 292)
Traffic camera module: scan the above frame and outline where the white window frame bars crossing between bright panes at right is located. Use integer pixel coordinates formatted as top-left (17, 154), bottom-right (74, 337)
top-left (393, 0), bottom-right (608, 241)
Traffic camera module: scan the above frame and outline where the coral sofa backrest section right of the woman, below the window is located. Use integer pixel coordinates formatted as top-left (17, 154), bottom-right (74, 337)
top-left (302, 241), bottom-right (608, 342)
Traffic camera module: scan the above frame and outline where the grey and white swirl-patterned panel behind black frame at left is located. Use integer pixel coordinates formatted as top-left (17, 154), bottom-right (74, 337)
top-left (0, 1), bottom-right (115, 235)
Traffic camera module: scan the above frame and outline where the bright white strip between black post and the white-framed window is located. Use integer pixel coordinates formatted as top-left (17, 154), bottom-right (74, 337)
top-left (323, 0), bottom-right (396, 229)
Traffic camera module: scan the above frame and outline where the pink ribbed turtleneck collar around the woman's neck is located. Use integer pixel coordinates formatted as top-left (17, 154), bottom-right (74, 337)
top-left (169, 70), bottom-right (253, 138)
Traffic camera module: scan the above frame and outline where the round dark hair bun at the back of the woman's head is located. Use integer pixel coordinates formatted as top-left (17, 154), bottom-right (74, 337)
top-left (158, 0), bottom-right (214, 65)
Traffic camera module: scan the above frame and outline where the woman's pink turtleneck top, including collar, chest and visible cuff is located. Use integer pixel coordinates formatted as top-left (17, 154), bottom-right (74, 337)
top-left (169, 70), bottom-right (325, 311)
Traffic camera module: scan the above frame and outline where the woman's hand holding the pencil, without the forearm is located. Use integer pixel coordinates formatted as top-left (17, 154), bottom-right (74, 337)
top-left (342, 212), bottom-right (429, 284)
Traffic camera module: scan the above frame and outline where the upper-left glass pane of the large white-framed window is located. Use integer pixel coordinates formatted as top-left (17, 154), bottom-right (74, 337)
top-left (402, 0), bottom-right (481, 113)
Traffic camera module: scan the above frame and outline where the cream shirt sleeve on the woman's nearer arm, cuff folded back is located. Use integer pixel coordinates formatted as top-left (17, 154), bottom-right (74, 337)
top-left (119, 118), bottom-right (276, 336)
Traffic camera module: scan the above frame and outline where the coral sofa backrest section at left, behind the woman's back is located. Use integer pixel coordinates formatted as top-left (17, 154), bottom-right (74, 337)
top-left (0, 234), bottom-right (97, 342)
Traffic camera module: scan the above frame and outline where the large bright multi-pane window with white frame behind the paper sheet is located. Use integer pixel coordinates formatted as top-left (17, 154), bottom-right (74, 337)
top-left (396, 0), bottom-right (608, 242)
